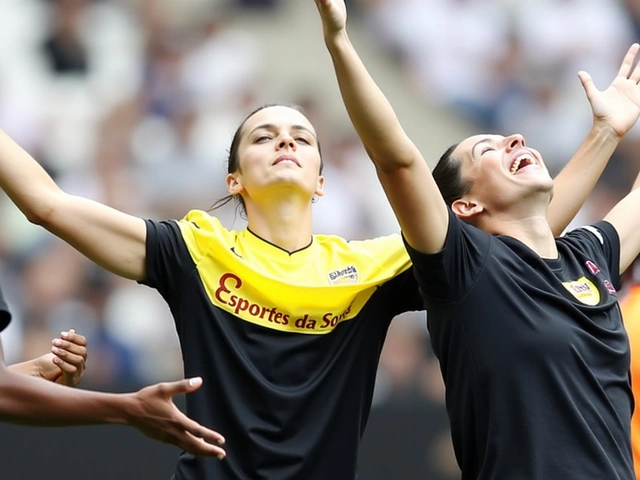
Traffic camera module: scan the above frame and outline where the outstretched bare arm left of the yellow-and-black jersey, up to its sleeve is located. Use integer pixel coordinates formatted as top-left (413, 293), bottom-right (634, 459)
top-left (0, 130), bottom-right (147, 280)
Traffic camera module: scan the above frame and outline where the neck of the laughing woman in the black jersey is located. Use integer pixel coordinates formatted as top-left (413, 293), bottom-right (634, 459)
top-left (478, 212), bottom-right (558, 259)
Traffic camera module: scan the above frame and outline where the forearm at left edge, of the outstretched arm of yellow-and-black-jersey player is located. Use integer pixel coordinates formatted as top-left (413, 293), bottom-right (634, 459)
top-left (0, 129), bottom-right (62, 223)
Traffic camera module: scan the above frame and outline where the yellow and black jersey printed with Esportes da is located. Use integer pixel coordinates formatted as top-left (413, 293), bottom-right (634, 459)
top-left (144, 211), bottom-right (423, 480)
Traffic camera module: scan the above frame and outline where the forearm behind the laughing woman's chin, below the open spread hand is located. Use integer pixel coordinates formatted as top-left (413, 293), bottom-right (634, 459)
top-left (548, 124), bottom-right (620, 235)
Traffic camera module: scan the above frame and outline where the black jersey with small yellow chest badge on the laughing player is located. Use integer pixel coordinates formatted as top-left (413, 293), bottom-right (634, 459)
top-left (409, 212), bottom-right (633, 480)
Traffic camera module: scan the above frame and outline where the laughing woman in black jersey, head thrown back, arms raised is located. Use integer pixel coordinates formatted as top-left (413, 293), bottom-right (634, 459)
top-left (316, 0), bottom-right (640, 480)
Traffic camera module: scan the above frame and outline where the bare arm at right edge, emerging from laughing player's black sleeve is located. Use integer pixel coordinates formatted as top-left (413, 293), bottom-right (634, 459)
top-left (604, 169), bottom-right (640, 274)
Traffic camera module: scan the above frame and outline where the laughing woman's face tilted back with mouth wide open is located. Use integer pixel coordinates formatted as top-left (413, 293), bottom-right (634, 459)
top-left (452, 130), bottom-right (553, 215)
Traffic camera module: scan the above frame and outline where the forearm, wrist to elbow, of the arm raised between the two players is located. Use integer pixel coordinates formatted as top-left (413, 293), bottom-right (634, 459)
top-left (324, 29), bottom-right (418, 170)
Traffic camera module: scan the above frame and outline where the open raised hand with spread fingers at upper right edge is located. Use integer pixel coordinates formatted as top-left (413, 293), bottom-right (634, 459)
top-left (578, 43), bottom-right (640, 137)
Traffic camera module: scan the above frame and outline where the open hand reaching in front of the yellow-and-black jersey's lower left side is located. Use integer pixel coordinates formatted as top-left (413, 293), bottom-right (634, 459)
top-left (130, 377), bottom-right (226, 460)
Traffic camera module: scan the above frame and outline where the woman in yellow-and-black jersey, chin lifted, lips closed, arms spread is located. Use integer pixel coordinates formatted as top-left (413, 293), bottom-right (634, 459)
top-left (0, 4), bottom-right (636, 480)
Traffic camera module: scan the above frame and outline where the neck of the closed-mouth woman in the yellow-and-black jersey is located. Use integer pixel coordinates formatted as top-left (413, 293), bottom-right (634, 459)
top-left (245, 198), bottom-right (312, 252)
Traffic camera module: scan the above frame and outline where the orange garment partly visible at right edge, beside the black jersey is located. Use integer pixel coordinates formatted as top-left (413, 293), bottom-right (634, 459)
top-left (620, 284), bottom-right (640, 480)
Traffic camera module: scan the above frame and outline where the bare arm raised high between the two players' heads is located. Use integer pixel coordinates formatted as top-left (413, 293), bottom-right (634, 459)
top-left (315, 0), bottom-right (449, 253)
